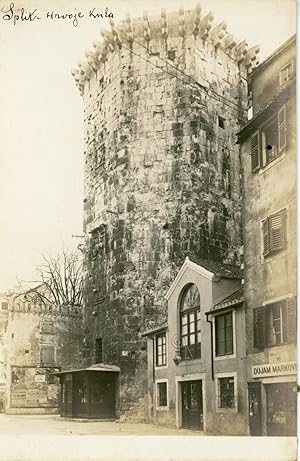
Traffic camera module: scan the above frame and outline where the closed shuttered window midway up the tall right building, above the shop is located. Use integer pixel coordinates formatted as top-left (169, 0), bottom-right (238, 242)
top-left (262, 209), bottom-right (286, 257)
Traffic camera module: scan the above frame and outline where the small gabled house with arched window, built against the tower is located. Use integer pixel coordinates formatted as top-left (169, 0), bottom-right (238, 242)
top-left (145, 258), bottom-right (248, 435)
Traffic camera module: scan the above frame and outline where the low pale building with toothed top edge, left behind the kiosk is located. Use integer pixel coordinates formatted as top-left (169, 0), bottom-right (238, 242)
top-left (5, 285), bottom-right (83, 414)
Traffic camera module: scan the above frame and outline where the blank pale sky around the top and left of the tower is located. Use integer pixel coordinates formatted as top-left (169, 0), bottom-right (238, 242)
top-left (0, 0), bottom-right (296, 291)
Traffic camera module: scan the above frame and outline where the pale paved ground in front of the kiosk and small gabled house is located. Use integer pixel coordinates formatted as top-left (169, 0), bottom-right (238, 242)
top-left (0, 414), bottom-right (202, 436)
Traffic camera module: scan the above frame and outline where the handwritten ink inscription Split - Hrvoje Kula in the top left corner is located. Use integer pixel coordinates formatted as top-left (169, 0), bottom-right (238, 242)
top-left (0, 3), bottom-right (114, 27)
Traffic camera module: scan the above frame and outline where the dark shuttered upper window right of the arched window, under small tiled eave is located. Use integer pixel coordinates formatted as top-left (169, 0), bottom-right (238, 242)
top-left (215, 311), bottom-right (233, 357)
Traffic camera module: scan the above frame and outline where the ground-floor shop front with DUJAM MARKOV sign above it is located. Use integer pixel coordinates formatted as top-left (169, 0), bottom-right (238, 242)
top-left (248, 362), bottom-right (297, 436)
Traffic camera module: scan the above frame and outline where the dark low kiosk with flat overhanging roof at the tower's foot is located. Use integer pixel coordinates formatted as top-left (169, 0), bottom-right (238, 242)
top-left (56, 364), bottom-right (120, 419)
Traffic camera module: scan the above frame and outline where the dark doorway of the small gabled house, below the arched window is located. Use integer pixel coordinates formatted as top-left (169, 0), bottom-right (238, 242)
top-left (181, 380), bottom-right (203, 431)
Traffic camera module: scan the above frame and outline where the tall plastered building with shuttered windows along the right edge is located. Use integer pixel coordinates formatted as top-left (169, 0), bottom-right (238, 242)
top-left (239, 37), bottom-right (297, 435)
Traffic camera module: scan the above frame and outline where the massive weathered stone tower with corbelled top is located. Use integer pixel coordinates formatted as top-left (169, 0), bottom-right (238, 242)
top-left (73, 6), bottom-right (258, 411)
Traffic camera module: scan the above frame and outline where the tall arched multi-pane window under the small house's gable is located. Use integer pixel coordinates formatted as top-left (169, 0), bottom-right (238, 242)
top-left (180, 284), bottom-right (201, 359)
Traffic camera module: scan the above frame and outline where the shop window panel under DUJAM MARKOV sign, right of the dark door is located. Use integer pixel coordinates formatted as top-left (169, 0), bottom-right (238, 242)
top-left (265, 383), bottom-right (297, 436)
